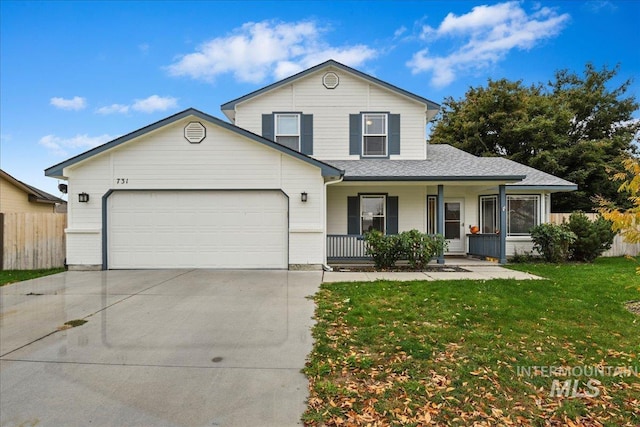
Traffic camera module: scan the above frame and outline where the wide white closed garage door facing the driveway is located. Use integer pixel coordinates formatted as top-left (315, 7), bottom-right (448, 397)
top-left (107, 191), bottom-right (288, 269)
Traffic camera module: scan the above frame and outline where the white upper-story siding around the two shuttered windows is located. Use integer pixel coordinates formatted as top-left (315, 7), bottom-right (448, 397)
top-left (235, 69), bottom-right (426, 160)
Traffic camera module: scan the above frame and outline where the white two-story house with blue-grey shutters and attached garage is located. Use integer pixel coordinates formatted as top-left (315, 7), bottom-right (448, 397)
top-left (45, 61), bottom-right (576, 269)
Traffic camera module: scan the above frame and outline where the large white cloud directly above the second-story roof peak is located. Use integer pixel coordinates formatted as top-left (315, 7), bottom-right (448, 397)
top-left (167, 21), bottom-right (377, 83)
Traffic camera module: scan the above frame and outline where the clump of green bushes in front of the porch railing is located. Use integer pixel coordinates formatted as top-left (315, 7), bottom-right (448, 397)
top-left (365, 230), bottom-right (446, 270)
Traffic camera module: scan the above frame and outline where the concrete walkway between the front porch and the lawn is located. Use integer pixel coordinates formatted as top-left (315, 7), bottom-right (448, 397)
top-left (322, 258), bottom-right (542, 283)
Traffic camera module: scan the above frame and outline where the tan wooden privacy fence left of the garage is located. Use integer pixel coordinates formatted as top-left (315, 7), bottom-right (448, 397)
top-left (0, 212), bottom-right (67, 270)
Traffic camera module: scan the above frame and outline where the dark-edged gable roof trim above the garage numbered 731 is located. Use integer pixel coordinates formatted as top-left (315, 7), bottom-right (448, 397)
top-left (44, 108), bottom-right (342, 178)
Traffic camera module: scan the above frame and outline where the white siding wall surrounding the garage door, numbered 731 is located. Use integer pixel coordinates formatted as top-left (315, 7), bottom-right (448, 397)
top-left (64, 118), bottom-right (324, 267)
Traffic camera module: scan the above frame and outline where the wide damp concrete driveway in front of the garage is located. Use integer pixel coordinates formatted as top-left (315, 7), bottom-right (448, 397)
top-left (0, 270), bottom-right (322, 427)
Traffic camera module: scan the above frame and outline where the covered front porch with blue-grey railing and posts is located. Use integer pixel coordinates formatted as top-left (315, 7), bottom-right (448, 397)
top-left (326, 182), bottom-right (507, 265)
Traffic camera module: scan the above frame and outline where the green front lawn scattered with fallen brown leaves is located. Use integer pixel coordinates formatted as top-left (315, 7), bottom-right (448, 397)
top-left (303, 258), bottom-right (640, 426)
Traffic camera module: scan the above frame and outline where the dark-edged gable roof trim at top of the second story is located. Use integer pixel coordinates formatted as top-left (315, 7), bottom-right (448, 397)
top-left (220, 59), bottom-right (440, 118)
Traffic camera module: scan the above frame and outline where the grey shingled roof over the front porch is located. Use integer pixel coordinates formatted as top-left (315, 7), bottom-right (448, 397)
top-left (330, 144), bottom-right (577, 191)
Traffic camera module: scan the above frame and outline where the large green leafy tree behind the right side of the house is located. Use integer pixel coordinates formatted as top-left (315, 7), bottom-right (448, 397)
top-left (431, 64), bottom-right (640, 212)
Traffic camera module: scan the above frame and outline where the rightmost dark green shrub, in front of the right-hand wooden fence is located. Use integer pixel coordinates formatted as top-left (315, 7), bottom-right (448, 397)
top-left (566, 212), bottom-right (616, 262)
